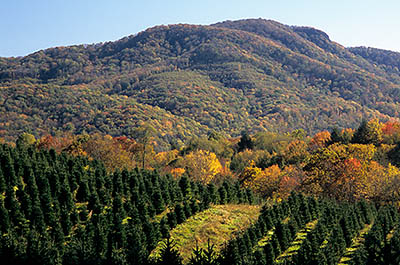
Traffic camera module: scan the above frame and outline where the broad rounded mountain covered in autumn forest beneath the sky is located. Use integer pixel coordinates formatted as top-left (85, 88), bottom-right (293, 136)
top-left (0, 19), bottom-right (400, 146)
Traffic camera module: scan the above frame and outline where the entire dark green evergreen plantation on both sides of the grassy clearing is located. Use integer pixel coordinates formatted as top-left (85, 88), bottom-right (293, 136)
top-left (0, 145), bottom-right (400, 265)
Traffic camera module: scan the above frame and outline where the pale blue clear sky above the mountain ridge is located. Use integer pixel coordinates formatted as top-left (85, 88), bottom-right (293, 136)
top-left (0, 0), bottom-right (400, 57)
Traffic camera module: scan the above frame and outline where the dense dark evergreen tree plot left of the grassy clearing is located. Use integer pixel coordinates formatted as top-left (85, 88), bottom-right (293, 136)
top-left (0, 145), bottom-right (255, 264)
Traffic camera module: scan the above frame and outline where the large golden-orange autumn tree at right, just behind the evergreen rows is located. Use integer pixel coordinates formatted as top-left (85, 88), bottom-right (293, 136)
top-left (302, 141), bottom-right (400, 201)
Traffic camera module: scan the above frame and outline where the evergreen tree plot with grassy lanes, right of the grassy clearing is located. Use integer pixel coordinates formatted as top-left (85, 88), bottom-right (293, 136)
top-left (156, 194), bottom-right (400, 265)
